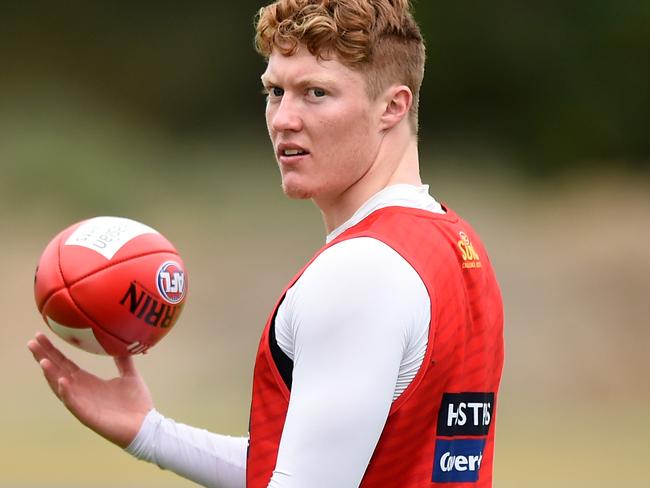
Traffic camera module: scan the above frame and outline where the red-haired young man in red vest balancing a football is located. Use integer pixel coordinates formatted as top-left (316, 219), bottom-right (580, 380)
top-left (29, 0), bottom-right (503, 488)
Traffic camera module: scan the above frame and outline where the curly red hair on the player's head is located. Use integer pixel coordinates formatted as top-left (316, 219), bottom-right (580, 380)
top-left (255, 0), bottom-right (425, 131)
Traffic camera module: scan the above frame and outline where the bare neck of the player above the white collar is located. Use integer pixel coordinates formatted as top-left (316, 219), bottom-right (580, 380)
top-left (314, 136), bottom-right (422, 233)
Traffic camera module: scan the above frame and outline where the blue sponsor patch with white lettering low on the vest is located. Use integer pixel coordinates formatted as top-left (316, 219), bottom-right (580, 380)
top-left (432, 439), bottom-right (485, 483)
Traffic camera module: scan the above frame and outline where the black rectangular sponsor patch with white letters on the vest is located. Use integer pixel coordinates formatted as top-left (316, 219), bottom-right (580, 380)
top-left (437, 392), bottom-right (494, 437)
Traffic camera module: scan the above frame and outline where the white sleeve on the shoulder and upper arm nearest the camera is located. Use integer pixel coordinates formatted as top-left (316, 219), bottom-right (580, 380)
top-left (269, 238), bottom-right (430, 488)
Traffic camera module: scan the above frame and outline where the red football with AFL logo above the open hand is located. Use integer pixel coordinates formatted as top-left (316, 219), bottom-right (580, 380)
top-left (34, 217), bottom-right (187, 356)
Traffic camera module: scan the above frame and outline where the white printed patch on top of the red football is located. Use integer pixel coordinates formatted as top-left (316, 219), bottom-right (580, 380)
top-left (65, 217), bottom-right (158, 260)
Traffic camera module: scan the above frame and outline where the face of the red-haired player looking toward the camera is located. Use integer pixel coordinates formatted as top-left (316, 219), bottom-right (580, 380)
top-left (262, 46), bottom-right (381, 204)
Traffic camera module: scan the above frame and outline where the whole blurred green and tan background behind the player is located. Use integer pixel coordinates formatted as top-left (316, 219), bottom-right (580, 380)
top-left (0, 0), bottom-right (650, 488)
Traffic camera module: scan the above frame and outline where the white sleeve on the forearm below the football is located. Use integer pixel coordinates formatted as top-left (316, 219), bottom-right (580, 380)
top-left (126, 410), bottom-right (248, 488)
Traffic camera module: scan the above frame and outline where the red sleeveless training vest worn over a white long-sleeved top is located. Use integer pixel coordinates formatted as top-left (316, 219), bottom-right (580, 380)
top-left (246, 207), bottom-right (504, 488)
